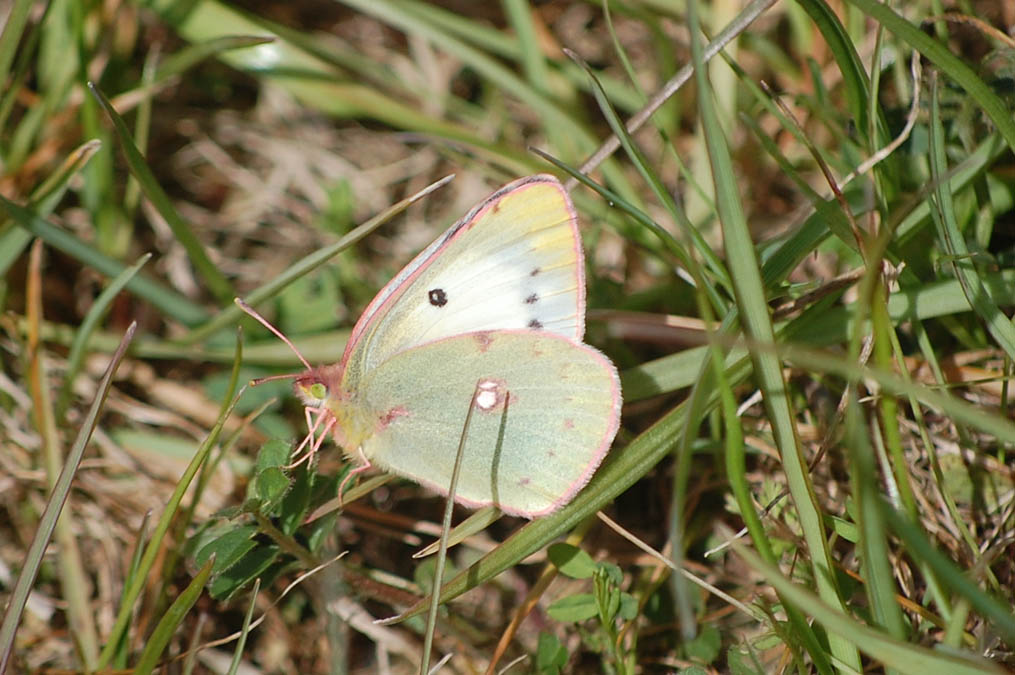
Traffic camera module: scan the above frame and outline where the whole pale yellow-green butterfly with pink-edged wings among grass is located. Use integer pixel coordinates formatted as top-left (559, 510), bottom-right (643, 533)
top-left (241, 175), bottom-right (621, 518)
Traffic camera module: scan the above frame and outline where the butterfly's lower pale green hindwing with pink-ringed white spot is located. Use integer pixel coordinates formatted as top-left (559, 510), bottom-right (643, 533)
top-left (359, 331), bottom-right (620, 518)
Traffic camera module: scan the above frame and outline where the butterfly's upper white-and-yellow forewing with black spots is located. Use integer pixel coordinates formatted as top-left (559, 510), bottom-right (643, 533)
top-left (343, 176), bottom-right (585, 388)
